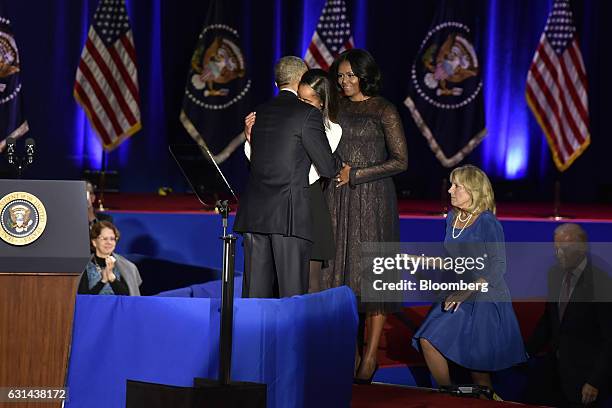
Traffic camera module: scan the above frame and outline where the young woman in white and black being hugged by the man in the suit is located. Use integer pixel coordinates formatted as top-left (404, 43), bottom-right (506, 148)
top-left (244, 69), bottom-right (342, 293)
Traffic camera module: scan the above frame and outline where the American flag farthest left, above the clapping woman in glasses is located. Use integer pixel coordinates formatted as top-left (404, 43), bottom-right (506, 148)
top-left (74, 0), bottom-right (141, 151)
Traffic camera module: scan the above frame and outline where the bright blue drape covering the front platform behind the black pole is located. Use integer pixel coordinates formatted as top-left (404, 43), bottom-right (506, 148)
top-left (66, 287), bottom-right (357, 408)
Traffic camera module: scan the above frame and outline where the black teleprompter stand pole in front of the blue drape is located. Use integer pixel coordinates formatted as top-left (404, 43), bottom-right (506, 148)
top-left (217, 200), bottom-right (236, 385)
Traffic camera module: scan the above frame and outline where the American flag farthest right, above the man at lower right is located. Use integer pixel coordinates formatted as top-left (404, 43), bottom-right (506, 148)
top-left (526, 0), bottom-right (591, 171)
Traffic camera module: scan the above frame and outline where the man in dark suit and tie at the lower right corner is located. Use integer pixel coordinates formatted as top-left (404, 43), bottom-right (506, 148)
top-left (527, 224), bottom-right (612, 407)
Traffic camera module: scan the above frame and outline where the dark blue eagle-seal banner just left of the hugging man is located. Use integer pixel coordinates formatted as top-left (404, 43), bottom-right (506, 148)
top-left (180, 0), bottom-right (251, 167)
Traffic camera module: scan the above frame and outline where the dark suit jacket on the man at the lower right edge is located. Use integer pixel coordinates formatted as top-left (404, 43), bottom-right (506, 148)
top-left (527, 261), bottom-right (612, 395)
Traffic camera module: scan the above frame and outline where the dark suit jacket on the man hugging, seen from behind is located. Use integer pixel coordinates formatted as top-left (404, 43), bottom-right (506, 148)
top-left (234, 91), bottom-right (342, 241)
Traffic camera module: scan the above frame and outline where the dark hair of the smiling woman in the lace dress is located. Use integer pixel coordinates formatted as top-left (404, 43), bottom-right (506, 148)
top-left (329, 48), bottom-right (382, 96)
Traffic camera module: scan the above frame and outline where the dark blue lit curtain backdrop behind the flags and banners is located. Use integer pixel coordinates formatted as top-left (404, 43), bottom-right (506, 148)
top-left (0, 0), bottom-right (612, 201)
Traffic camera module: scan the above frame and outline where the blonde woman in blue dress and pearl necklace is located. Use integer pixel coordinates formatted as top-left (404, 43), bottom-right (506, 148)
top-left (412, 165), bottom-right (526, 396)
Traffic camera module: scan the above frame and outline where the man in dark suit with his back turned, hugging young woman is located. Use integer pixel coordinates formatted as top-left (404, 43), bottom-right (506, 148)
top-left (234, 57), bottom-right (341, 297)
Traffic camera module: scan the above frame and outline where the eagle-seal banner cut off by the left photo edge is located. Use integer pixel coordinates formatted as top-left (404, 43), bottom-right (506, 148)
top-left (0, 3), bottom-right (29, 152)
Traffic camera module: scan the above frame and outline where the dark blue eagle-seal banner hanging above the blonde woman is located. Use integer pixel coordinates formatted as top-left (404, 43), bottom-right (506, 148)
top-left (404, 0), bottom-right (486, 167)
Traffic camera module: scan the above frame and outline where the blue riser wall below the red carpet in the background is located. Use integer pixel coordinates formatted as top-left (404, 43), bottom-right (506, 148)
top-left (112, 212), bottom-right (612, 301)
